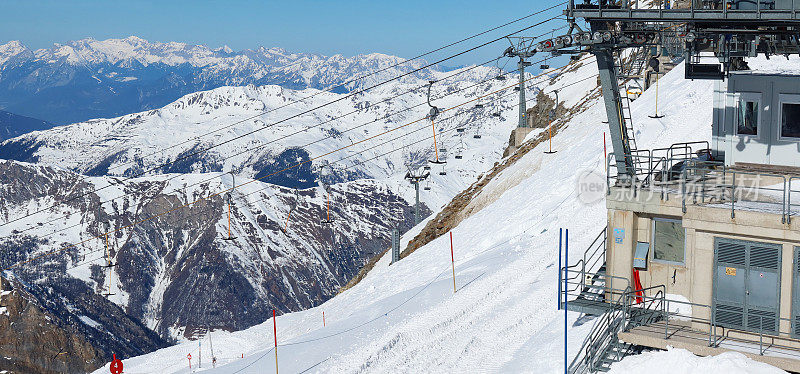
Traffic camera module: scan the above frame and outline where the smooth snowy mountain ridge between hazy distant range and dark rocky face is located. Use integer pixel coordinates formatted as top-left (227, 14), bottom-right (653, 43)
top-left (0, 67), bottom-right (520, 210)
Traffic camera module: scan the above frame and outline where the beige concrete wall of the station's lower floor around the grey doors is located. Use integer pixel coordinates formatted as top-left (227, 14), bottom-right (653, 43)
top-left (606, 188), bottom-right (800, 337)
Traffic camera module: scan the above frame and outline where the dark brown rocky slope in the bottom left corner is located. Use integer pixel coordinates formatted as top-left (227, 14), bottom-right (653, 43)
top-left (0, 278), bottom-right (166, 373)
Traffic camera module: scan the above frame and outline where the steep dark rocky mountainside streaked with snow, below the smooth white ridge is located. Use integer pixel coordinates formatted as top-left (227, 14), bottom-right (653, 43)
top-left (0, 161), bottom-right (429, 354)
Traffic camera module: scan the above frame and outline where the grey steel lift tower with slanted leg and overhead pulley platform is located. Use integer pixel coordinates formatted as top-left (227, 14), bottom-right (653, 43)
top-left (528, 0), bottom-right (800, 181)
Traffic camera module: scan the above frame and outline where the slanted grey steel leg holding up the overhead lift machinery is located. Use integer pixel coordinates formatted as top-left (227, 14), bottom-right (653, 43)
top-left (592, 49), bottom-right (634, 180)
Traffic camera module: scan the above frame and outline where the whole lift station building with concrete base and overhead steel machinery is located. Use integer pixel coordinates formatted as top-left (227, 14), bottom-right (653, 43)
top-left (552, 0), bottom-right (800, 373)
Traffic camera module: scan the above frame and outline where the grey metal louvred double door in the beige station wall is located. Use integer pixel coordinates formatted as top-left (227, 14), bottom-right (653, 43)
top-left (713, 238), bottom-right (781, 332)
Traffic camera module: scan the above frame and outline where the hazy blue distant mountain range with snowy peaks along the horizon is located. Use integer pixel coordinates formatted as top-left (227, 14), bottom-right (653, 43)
top-left (0, 36), bottom-right (436, 124)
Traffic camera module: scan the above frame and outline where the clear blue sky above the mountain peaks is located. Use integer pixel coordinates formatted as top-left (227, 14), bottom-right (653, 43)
top-left (0, 0), bottom-right (564, 64)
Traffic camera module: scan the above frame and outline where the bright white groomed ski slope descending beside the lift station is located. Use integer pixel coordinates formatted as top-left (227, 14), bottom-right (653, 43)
top-left (97, 57), bottom-right (788, 373)
